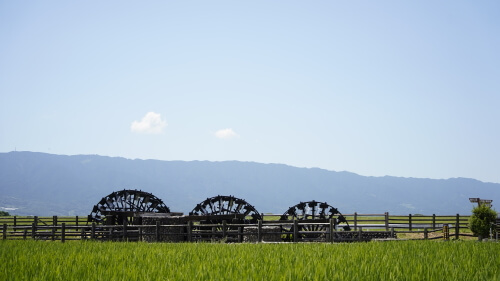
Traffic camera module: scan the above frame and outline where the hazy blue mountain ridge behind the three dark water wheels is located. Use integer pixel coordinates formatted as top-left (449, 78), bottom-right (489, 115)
top-left (0, 152), bottom-right (500, 216)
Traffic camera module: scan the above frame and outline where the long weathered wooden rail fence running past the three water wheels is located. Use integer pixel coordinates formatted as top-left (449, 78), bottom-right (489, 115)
top-left (0, 213), bottom-right (471, 242)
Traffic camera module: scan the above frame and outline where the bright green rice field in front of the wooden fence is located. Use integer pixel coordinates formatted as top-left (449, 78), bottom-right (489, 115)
top-left (0, 240), bottom-right (500, 281)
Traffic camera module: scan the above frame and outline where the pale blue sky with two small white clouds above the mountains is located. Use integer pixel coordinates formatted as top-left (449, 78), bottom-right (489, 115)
top-left (0, 1), bottom-right (500, 183)
